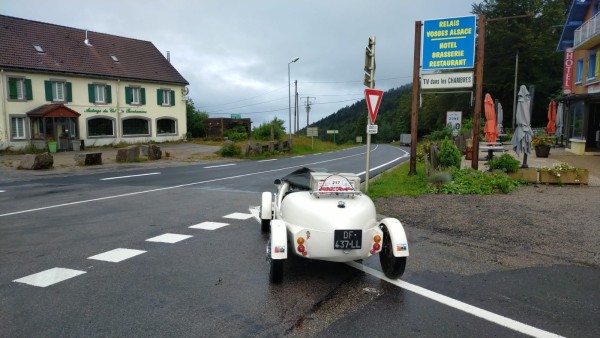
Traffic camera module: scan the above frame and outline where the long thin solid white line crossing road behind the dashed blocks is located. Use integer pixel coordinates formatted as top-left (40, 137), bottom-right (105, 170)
top-left (0, 150), bottom-right (392, 217)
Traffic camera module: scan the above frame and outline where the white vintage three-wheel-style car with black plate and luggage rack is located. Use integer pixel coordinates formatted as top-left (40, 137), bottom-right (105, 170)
top-left (260, 168), bottom-right (408, 283)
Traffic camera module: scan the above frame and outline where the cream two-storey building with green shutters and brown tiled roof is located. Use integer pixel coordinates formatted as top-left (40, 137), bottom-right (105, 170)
top-left (0, 15), bottom-right (188, 150)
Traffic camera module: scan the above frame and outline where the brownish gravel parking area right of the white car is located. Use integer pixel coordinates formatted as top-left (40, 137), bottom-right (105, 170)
top-left (375, 185), bottom-right (600, 274)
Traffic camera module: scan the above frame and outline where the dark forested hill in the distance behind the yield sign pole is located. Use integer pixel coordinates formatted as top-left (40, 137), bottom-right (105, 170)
top-left (299, 84), bottom-right (412, 143)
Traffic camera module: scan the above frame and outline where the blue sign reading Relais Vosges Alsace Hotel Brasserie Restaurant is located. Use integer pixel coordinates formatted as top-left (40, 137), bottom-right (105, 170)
top-left (421, 15), bottom-right (476, 70)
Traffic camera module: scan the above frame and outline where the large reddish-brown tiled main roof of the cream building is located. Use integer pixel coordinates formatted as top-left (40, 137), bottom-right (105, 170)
top-left (0, 15), bottom-right (188, 85)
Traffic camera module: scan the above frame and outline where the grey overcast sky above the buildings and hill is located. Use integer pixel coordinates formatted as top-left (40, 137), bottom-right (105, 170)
top-left (0, 0), bottom-right (480, 128)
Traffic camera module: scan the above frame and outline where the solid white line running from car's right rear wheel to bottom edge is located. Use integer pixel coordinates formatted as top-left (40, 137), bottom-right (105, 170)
top-left (346, 262), bottom-right (561, 337)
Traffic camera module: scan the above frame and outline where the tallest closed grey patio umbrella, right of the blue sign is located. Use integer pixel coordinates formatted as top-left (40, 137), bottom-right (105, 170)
top-left (511, 85), bottom-right (532, 161)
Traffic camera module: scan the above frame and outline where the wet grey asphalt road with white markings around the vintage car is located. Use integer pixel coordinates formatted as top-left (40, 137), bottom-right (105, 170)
top-left (0, 146), bottom-right (597, 337)
